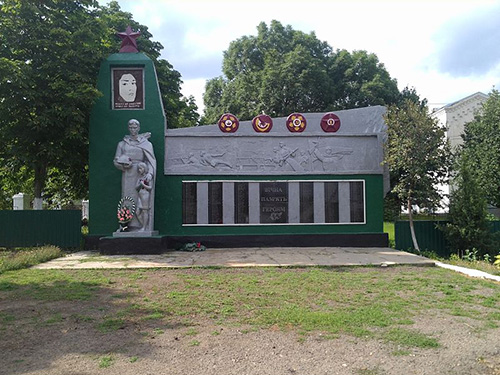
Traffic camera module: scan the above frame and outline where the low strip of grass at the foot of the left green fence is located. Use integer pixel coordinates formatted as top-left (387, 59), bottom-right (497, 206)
top-left (0, 246), bottom-right (63, 274)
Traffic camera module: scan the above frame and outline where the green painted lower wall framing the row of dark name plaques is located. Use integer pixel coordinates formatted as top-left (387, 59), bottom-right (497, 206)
top-left (162, 175), bottom-right (383, 236)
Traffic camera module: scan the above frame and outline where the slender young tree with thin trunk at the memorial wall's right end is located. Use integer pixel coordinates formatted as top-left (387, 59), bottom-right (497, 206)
top-left (384, 99), bottom-right (450, 250)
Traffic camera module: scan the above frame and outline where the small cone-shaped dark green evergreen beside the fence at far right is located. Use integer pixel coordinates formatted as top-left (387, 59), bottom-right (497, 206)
top-left (443, 155), bottom-right (496, 257)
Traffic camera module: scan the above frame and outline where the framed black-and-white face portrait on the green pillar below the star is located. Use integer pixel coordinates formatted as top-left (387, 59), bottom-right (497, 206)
top-left (111, 68), bottom-right (144, 109)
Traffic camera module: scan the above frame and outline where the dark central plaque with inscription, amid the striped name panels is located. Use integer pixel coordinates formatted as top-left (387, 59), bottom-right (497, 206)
top-left (260, 182), bottom-right (288, 224)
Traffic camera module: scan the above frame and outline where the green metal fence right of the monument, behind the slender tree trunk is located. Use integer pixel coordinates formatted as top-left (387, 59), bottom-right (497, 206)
top-left (394, 220), bottom-right (500, 257)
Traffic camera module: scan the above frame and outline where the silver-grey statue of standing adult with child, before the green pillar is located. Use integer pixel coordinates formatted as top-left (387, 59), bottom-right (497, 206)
top-left (113, 119), bottom-right (156, 232)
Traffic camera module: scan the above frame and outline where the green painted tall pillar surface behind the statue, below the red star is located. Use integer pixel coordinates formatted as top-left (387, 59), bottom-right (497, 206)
top-left (89, 53), bottom-right (168, 235)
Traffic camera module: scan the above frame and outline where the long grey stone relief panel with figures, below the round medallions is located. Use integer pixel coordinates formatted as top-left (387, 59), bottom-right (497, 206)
top-left (165, 135), bottom-right (383, 175)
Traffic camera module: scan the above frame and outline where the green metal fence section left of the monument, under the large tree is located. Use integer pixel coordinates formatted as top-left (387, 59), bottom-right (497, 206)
top-left (0, 210), bottom-right (82, 248)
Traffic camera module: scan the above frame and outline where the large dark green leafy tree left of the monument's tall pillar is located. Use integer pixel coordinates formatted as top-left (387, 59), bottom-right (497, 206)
top-left (0, 0), bottom-right (105, 209)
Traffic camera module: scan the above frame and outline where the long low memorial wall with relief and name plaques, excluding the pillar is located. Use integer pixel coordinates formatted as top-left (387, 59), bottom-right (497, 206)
top-left (164, 106), bottom-right (388, 244)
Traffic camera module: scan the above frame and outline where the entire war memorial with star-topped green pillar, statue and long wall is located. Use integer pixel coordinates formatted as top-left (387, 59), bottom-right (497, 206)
top-left (89, 28), bottom-right (389, 254)
